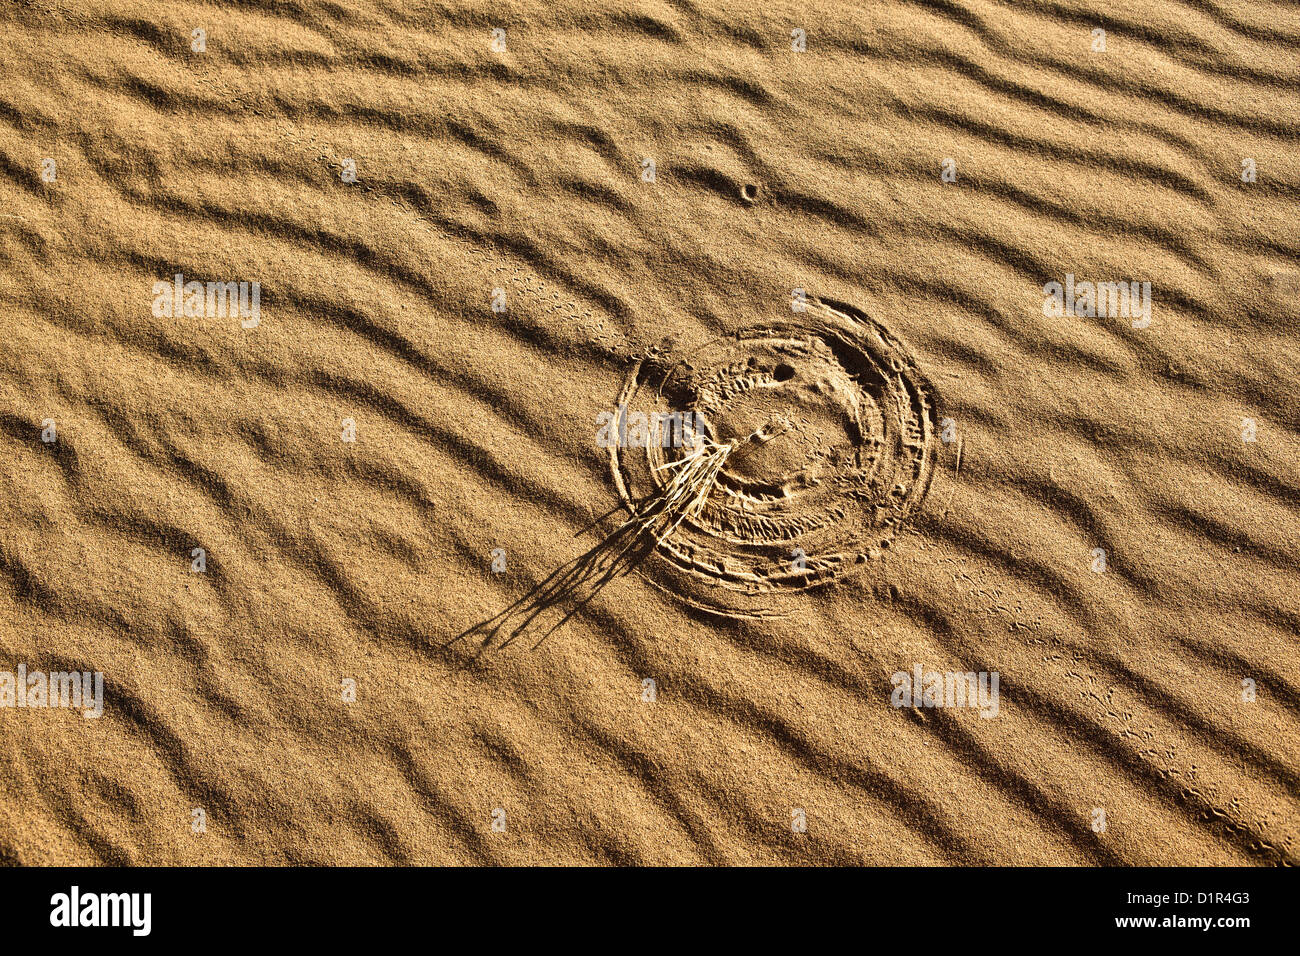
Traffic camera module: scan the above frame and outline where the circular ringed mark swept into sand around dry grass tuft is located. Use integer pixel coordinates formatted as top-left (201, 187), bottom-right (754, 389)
top-left (611, 299), bottom-right (933, 617)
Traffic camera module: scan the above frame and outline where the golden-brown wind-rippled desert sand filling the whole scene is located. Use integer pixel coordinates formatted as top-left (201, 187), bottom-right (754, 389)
top-left (0, 0), bottom-right (1300, 866)
